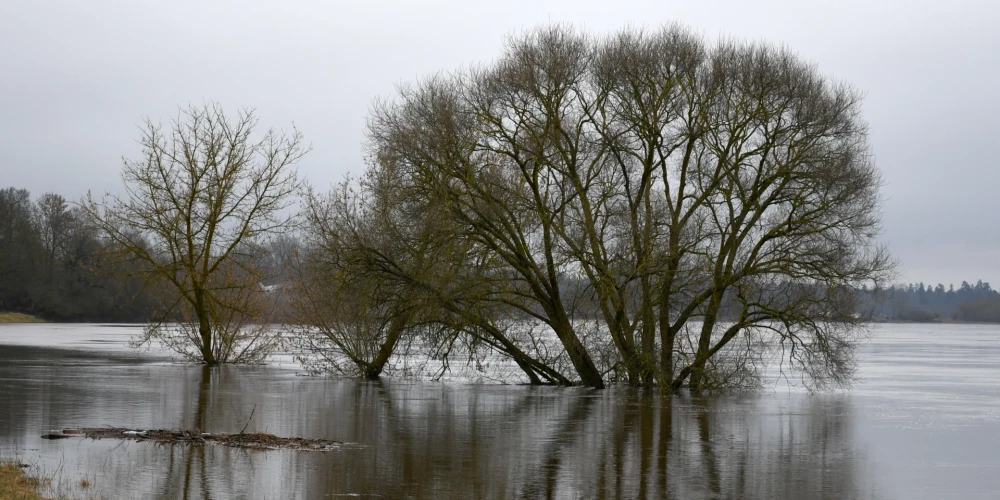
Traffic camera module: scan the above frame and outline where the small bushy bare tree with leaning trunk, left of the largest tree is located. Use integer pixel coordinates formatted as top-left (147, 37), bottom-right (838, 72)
top-left (290, 180), bottom-right (412, 378)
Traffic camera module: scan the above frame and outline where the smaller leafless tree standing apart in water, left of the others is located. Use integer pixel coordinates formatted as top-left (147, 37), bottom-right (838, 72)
top-left (84, 104), bottom-right (307, 365)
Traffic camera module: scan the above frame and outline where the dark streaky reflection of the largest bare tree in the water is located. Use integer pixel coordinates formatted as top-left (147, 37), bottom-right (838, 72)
top-left (300, 384), bottom-right (864, 499)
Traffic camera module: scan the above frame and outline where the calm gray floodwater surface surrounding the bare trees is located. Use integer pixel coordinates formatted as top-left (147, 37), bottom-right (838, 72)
top-left (0, 325), bottom-right (1000, 499)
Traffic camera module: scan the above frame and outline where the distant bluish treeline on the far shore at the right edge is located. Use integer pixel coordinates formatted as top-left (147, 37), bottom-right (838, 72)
top-left (873, 280), bottom-right (1000, 323)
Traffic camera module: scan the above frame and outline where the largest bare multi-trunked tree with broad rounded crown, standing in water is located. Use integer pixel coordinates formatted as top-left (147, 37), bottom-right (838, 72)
top-left (294, 26), bottom-right (893, 390)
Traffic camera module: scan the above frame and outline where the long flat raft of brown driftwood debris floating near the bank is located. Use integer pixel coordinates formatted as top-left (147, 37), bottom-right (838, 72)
top-left (42, 427), bottom-right (343, 451)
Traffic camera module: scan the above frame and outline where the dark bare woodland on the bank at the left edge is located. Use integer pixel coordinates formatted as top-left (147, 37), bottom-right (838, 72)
top-left (0, 187), bottom-right (152, 322)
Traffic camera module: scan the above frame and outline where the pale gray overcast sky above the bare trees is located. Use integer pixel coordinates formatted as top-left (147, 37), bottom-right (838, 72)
top-left (0, 0), bottom-right (1000, 287)
